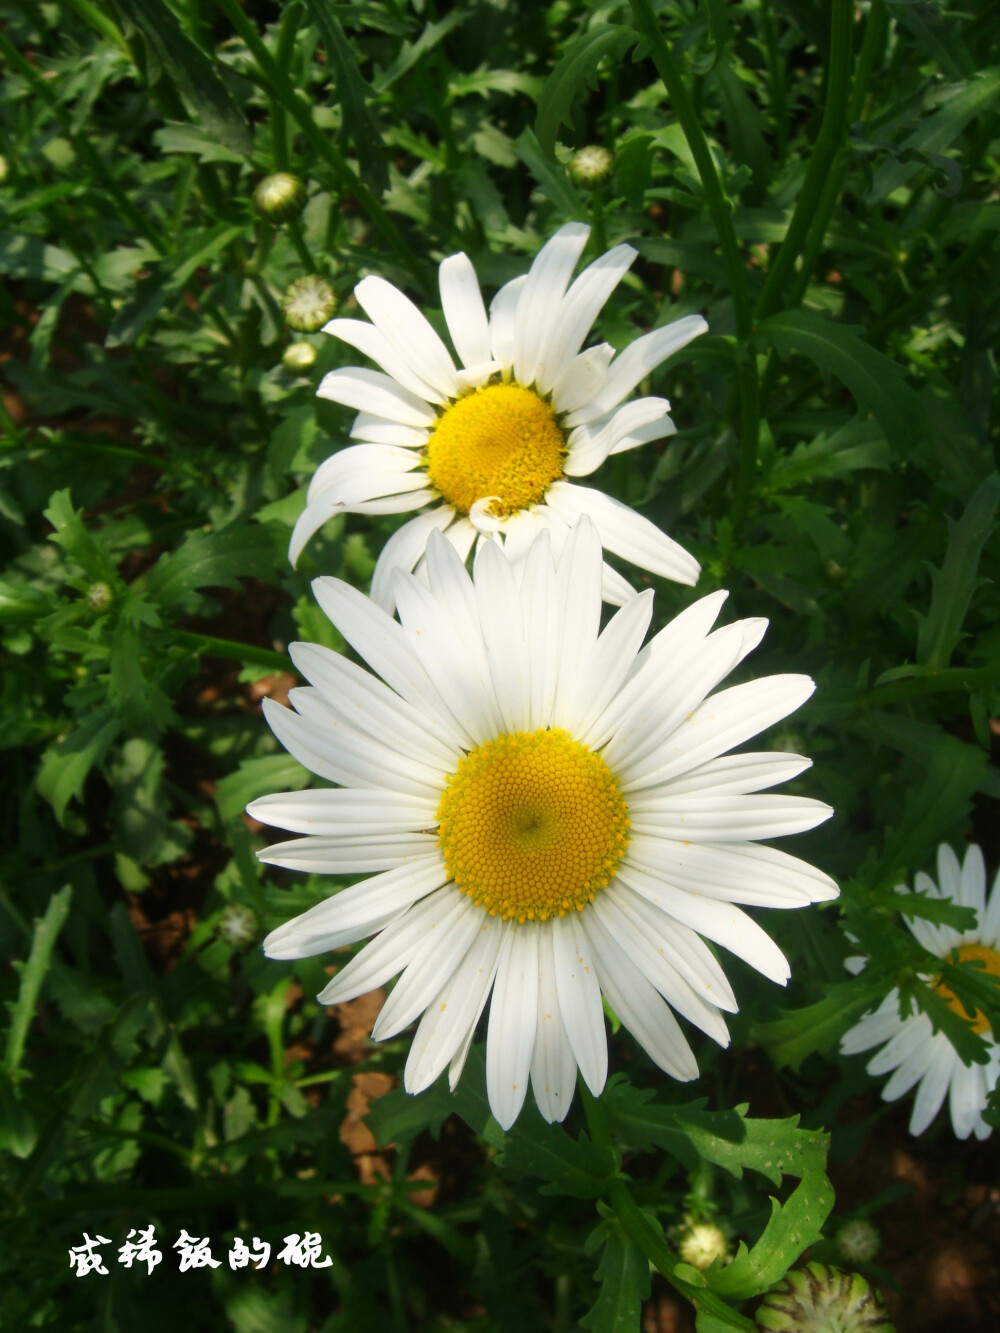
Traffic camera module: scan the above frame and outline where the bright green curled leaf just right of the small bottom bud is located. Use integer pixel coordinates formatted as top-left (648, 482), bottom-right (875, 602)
top-left (705, 1170), bottom-right (833, 1301)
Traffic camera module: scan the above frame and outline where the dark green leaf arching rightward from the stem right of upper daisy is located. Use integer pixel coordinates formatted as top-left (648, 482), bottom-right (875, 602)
top-left (757, 311), bottom-right (924, 452)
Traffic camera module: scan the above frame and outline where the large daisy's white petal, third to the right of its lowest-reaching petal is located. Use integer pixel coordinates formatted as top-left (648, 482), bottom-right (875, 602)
top-left (584, 913), bottom-right (697, 1082)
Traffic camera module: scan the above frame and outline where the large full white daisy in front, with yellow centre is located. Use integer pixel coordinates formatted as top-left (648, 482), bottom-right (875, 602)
top-left (248, 520), bottom-right (837, 1129)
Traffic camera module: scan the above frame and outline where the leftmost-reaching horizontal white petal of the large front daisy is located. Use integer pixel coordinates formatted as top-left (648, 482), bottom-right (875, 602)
top-left (247, 786), bottom-right (437, 836)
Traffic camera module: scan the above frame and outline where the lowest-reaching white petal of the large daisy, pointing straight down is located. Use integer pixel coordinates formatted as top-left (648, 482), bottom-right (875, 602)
top-left (487, 926), bottom-right (539, 1130)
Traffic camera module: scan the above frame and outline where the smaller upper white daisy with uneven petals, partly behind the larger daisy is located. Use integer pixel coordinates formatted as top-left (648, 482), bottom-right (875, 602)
top-left (288, 223), bottom-right (708, 611)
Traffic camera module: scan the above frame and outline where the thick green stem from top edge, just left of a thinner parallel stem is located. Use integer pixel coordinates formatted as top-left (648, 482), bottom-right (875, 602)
top-left (755, 0), bottom-right (853, 321)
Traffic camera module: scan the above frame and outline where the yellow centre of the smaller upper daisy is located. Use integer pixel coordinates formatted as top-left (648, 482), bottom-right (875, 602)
top-left (427, 384), bottom-right (567, 517)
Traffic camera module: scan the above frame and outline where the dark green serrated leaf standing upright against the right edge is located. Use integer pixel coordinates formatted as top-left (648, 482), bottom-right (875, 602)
top-left (917, 472), bottom-right (1000, 668)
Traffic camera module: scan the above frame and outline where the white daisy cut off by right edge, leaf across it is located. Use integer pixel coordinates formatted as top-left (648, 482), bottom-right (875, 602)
top-left (840, 842), bottom-right (1000, 1138)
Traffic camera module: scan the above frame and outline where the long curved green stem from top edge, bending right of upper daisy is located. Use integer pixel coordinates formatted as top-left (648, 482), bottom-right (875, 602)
top-left (629, 0), bottom-right (757, 532)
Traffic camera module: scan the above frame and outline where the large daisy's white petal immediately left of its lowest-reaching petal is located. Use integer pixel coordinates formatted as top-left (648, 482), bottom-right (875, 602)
top-left (403, 916), bottom-right (503, 1093)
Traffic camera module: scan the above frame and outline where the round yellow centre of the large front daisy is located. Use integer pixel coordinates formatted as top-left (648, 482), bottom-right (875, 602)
top-left (437, 730), bottom-right (628, 921)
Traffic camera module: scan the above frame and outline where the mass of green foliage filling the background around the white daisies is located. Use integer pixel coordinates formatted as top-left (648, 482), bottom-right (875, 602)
top-left (0, 0), bottom-right (1000, 1333)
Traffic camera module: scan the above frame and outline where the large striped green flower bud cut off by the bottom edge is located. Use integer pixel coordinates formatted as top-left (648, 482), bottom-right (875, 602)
top-left (756, 1264), bottom-right (895, 1333)
